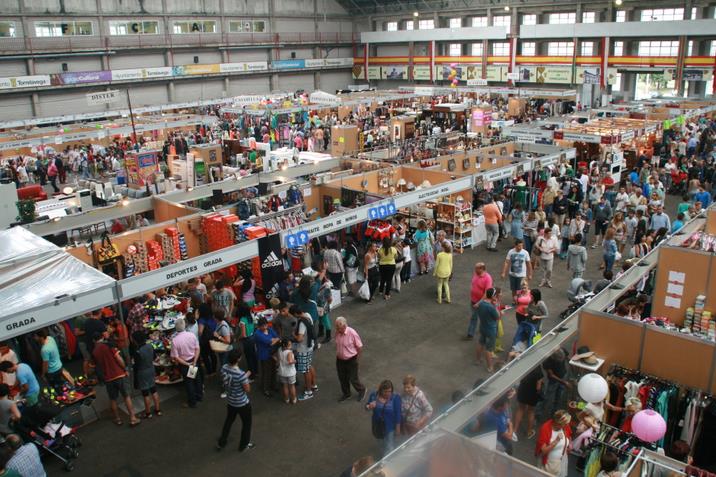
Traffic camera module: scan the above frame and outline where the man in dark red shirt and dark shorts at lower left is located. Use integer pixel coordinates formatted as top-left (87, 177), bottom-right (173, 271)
top-left (92, 334), bottom-right (141, 427)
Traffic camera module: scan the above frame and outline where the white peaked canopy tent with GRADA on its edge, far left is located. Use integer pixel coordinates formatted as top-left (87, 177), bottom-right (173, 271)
top-left (0, 227), bottom-right (117, 340)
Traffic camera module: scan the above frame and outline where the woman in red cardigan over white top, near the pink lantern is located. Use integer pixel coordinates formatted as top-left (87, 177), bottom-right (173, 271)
top-left (535, 410), bottom-right (572, 477)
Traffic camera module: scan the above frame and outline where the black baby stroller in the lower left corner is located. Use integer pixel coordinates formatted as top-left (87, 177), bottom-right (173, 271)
top-left (15, 403), bottom-right (82, 472)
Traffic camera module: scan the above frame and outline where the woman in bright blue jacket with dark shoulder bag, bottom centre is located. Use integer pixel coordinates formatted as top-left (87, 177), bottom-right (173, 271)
top-left (365, 379), bottom-right (402, 457)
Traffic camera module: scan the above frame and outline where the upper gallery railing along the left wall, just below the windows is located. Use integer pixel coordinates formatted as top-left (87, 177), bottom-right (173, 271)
top-left (0, 32), bottom-right (359, 54)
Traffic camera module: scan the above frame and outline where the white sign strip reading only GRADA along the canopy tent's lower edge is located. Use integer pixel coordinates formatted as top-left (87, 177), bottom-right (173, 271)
top-left (0, 284), bottom-right (114, 341)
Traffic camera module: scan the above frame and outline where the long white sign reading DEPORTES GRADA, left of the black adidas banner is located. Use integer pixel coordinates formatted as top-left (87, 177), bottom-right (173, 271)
top-left (118, 240), bottom-right (259, 300)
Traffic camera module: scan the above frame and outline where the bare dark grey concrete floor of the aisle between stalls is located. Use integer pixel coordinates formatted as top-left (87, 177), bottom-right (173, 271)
top-left (47, 229), bottom-right (601, 477)
